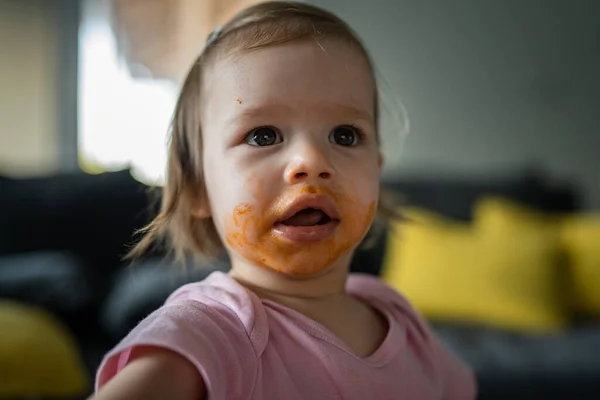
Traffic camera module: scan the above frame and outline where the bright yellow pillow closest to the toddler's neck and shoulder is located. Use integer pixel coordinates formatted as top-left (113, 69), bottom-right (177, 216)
top-left (382, 209), bottom-right (488, 320)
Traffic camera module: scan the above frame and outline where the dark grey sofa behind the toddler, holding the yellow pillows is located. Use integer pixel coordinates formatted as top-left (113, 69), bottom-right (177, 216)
top-left (0, 171), bottom-right (600, 400)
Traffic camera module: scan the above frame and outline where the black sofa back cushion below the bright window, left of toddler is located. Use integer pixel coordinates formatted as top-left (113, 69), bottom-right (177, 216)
top-left (0, 171), bottom-right (149, 268)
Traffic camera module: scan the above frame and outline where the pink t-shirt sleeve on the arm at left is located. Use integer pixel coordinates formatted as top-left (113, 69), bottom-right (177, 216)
top-left (96, 301), bottom-right (257, 399)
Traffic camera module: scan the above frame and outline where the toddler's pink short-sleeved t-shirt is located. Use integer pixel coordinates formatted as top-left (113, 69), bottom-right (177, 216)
top-left (96, 272), bottom-right (476, 400)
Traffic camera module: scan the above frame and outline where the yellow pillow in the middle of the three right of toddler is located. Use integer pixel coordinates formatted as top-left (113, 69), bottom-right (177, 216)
top-left (475, 197), bottom-right (568, 330)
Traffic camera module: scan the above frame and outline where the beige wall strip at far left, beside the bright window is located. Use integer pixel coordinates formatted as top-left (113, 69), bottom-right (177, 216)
top-left (0, 0), bottom-right (60, 176)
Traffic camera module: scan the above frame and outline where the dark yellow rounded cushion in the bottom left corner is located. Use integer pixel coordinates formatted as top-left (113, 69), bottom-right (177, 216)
top-left (0, 300), bottom-right (88, 398)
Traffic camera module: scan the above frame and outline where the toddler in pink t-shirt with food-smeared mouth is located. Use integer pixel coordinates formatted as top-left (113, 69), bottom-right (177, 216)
top-left (94, 1), bottom-right (476, 400)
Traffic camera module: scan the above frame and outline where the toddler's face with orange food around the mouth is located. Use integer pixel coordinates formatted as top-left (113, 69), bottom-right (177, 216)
top-left (201, 41), bottom-right (381, 276)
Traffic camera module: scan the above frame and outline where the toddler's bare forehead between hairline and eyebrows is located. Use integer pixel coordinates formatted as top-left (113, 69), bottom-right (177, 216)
top-left (202, 40), bottom-right (375, 125)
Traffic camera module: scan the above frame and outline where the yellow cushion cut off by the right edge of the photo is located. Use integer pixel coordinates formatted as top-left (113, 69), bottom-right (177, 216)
top-left (560, 214), bottom-right (600, 317)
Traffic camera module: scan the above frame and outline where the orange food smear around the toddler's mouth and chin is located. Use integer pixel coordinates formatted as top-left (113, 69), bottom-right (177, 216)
top-left (224, 185), bottom-right (376, 276)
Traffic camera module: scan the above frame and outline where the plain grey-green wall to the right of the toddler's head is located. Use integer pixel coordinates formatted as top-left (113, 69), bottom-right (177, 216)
top-left (312, 0), bottom-right (600, 209)
